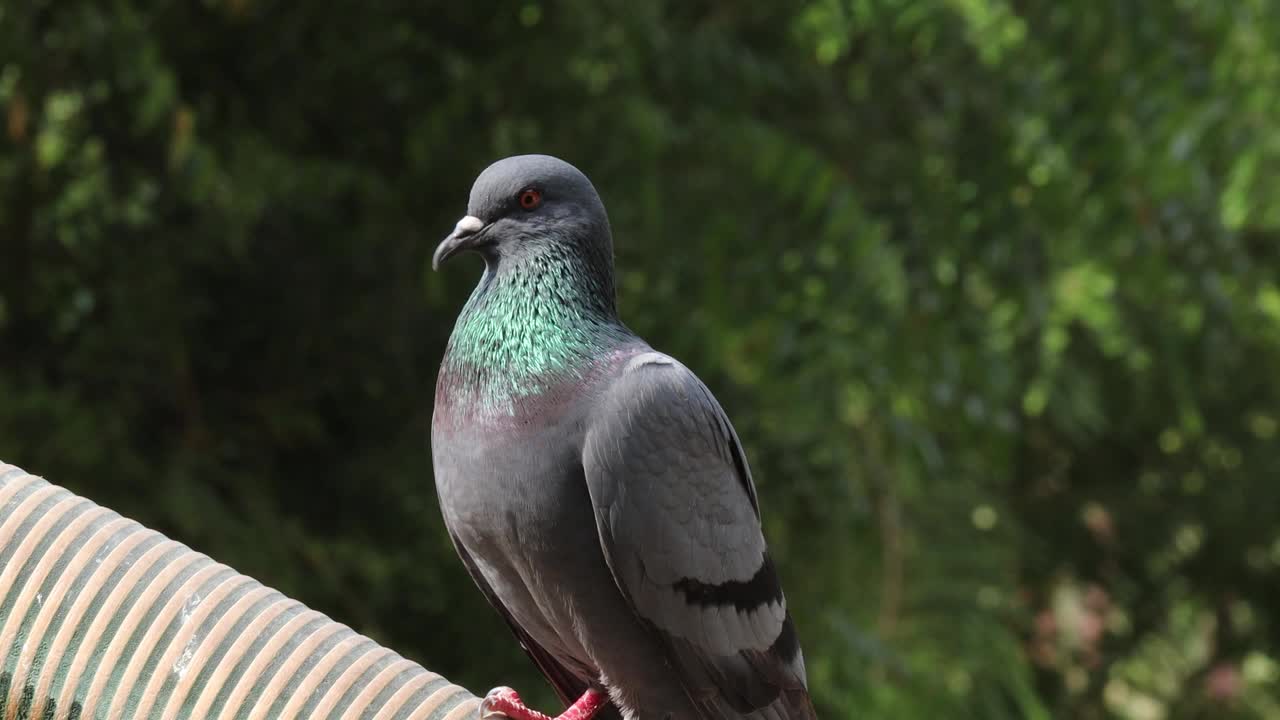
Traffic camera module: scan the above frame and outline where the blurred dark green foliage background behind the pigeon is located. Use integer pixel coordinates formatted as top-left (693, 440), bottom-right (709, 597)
top-left (0, 0), bottom-right (1280, 720)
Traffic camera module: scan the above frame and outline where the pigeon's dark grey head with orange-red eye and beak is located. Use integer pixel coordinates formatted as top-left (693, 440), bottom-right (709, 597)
top-left (431, 155), bottom-right (613, 269)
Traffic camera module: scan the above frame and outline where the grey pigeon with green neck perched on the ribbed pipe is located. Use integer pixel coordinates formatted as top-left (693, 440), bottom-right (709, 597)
top-left (431, 155), bottom-right (815, 720)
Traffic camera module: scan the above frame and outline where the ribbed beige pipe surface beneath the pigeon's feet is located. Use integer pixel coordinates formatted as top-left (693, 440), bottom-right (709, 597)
top-left (0, 462), bottom-right (477, 720)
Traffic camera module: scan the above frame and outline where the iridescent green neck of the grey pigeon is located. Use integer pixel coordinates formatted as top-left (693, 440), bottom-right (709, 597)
top-left (440, 250), bottom-right (631, 415)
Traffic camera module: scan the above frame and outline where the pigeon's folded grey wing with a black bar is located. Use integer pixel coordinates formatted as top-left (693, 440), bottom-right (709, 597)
top-left (582, 352), bottom-right (814, 719)
